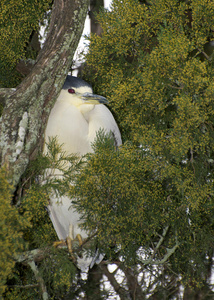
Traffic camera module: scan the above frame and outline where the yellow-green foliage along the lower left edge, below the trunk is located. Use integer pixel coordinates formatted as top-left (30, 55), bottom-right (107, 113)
top-left (0, 169), bottom-right (29, 295)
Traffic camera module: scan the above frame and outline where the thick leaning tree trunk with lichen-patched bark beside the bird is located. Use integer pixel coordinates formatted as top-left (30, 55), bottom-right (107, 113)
top-left (0, 0), bottom-right (88, 187)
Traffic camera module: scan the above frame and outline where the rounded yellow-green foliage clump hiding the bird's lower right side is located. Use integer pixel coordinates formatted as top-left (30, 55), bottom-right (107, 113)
top-left (72, 134), bottom-right (214, 277)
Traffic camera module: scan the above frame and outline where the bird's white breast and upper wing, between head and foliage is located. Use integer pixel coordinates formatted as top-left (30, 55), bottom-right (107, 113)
top-left (45, 91), bottom-right (122, 155)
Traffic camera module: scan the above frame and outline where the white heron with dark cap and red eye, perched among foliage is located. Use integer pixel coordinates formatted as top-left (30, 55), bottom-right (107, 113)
top-left (44, 75), bottom-right (122, 271)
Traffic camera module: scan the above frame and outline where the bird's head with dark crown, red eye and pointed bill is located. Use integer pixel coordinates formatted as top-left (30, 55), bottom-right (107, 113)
top-left (61, 75), bottom-right (108, 108)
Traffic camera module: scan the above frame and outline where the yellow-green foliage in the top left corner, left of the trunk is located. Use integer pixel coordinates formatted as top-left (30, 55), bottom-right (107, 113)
top-left (0, 0), bottom-right (51, 87)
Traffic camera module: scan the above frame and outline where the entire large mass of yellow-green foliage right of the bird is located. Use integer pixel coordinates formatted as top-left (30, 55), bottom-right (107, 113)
top-left (82, 0), bottom-right (214, 290)
